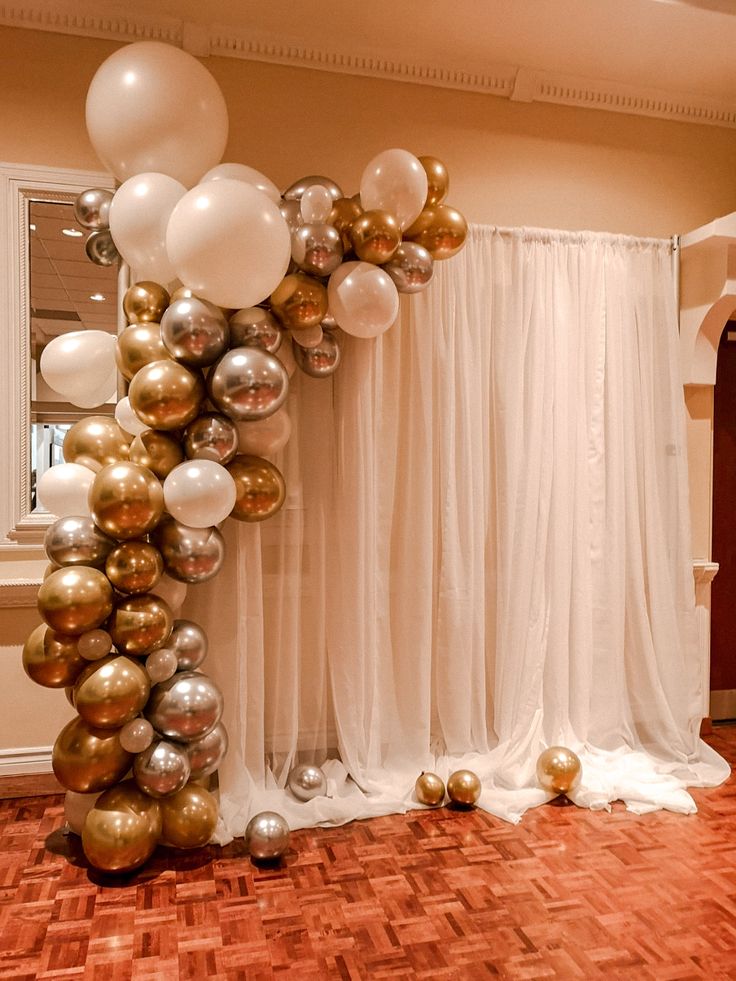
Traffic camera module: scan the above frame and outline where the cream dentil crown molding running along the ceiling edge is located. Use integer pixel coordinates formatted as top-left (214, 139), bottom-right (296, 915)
top-left (5, 0), bottom-right (736, 129)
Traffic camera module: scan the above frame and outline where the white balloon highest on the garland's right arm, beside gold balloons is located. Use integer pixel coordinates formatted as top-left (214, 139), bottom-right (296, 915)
top-left (360, 149), bottom-right (428, 228)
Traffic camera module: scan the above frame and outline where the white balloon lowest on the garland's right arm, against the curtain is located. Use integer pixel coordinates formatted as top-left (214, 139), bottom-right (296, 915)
top-left (327, 262), bottom-right (399, 337)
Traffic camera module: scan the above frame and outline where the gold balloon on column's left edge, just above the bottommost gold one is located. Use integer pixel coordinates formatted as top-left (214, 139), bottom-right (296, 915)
top-left (51, 716), bottom-right (133, 794)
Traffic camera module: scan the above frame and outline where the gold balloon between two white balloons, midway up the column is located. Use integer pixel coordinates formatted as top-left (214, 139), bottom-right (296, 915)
top-left (89, 461), bottom-right (164, 540)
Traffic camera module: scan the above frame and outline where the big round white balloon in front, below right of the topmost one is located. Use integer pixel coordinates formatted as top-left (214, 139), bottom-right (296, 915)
top-left (166, 178), bottom-right (291, 310)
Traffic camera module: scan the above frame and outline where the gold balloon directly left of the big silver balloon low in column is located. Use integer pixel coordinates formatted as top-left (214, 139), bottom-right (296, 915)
top-left (74, 654), bottom-right (151, 729)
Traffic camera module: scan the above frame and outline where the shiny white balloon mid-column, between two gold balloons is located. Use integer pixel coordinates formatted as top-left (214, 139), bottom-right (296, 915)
top-left (164, 460), bottom-right (237, 528)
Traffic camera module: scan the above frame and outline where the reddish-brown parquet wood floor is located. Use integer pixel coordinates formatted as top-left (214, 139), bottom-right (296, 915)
top-left (0, 727), bottom-right (736, 981)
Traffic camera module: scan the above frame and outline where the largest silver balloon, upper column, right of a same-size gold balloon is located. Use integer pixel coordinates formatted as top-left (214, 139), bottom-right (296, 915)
top-left (207, 347), bottom-right (289, 422)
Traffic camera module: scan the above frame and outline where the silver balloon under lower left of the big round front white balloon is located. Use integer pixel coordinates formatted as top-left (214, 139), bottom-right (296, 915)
top-left (161, 296), bottom-right (230, 368)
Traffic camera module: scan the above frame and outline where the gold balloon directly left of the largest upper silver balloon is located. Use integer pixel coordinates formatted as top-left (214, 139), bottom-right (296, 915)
top-left (128, 360), bottom-right (206, 429)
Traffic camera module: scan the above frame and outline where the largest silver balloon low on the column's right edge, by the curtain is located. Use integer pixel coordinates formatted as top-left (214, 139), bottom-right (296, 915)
top-left (144, 671), bottom-right (223, 742)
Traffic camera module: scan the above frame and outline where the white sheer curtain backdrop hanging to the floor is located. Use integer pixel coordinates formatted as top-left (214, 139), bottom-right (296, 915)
top-left (185, 226), bottom-right (728, 841)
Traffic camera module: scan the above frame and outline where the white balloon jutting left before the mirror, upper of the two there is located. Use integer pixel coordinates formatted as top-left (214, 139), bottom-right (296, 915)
top-left (40, 330), bottom-right (117, 409)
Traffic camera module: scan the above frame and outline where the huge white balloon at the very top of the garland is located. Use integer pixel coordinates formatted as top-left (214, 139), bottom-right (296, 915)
top-left (87, 41), bottom-right (228, 187)
